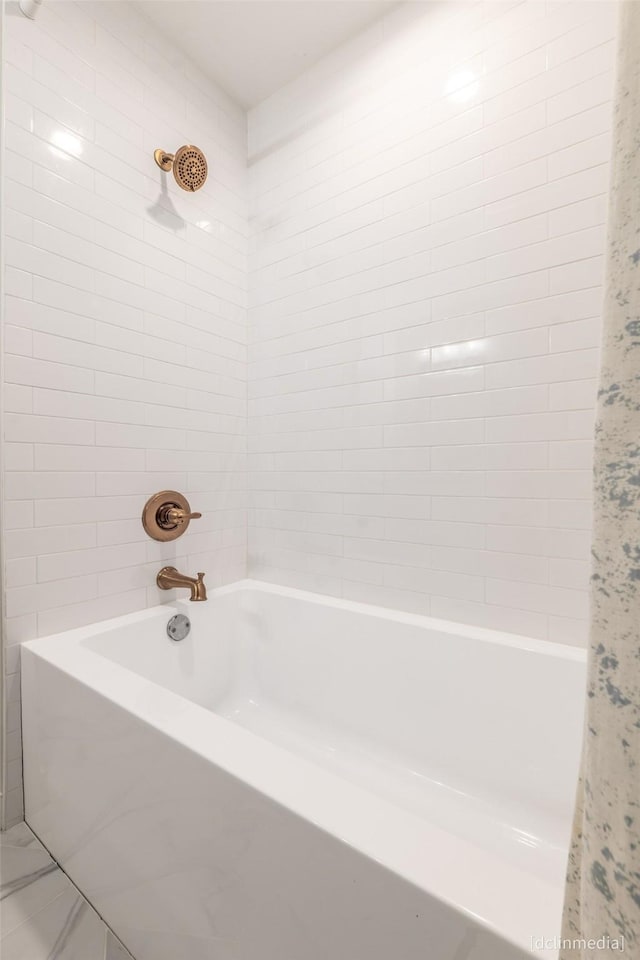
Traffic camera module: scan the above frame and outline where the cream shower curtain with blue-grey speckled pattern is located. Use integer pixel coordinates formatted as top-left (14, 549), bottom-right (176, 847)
top-left (560, 0), bottom-right (640, 960)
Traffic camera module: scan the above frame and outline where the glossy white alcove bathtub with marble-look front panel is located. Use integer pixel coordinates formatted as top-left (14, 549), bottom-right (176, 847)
top-left (23, 581), bottom-right (584, 960)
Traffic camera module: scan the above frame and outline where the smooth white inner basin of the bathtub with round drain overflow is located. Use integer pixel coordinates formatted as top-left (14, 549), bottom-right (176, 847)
top-left (83, 583), bottom-right (584, 883)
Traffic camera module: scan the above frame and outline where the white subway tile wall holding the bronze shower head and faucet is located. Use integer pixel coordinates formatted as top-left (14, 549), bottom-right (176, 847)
top-left (4, 2), bottom-right (247, 824)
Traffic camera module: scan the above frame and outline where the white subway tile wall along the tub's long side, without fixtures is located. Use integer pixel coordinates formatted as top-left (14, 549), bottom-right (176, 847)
top-left (249, 2), bottom-right (616, 643)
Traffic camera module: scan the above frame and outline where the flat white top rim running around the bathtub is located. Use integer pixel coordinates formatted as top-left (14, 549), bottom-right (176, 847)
top-left (22, 579), bottom-right (586, 958)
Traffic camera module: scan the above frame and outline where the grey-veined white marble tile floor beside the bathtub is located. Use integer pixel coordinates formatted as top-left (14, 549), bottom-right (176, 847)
top-left (0, 823), bottom-right (133, 960)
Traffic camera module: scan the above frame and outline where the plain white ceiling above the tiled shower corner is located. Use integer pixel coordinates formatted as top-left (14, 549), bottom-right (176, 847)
top-left (137, 0), bottom-right (396, 107)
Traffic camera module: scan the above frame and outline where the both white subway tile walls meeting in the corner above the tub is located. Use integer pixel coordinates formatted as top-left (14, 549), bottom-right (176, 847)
top-left (3, 0), bottom-right (616, 823)
